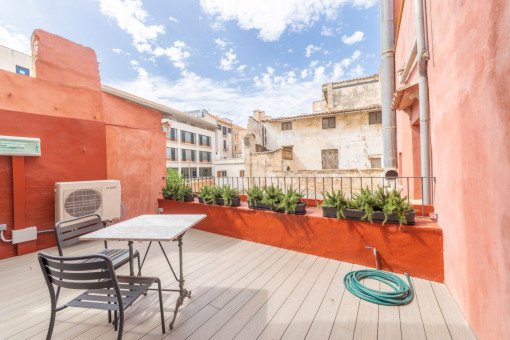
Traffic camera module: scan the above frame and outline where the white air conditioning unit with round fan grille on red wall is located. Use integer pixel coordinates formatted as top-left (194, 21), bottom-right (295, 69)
top-left (55, 180), bottom-right (120, 223)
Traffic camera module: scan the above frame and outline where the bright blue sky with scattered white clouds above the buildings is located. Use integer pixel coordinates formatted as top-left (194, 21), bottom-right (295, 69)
top-left (0, 0), bottom-right (380, 126)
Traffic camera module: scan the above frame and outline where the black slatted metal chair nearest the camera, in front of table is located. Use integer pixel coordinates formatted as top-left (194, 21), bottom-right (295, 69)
top-left (39, 253), bottom-right (165, 340)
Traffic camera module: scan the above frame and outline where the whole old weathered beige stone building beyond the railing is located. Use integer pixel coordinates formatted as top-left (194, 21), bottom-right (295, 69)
top-left (245, 75), bottom-right (382, 176)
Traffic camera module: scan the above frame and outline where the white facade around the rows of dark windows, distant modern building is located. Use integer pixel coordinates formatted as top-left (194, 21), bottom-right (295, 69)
top-left (162, 119), bottom-right (216, 176)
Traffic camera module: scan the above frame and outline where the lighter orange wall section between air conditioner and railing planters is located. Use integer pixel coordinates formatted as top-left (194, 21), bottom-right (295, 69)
top-left (103, 93), bottom-right (166, 218)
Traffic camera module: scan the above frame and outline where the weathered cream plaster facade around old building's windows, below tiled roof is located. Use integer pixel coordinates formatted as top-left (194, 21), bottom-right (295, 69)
top-left (264, 112), bottom-right (382, 171)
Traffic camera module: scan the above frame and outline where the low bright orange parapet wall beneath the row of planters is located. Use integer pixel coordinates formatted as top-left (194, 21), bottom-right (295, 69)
top-left (159, 199), bottom-right (444, 282)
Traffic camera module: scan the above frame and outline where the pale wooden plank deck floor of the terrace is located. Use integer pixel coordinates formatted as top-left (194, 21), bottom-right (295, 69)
top-left (0, 230), bottom-right (475, 340)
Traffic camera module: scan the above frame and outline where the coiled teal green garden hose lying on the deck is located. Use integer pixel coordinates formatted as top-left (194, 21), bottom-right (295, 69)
top-left (344, 269), bottom-right (414, 306)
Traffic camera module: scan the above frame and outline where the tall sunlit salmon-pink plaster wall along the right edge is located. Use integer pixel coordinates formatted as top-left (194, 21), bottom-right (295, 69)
top-left (396, 0), bottom-right (510, 339)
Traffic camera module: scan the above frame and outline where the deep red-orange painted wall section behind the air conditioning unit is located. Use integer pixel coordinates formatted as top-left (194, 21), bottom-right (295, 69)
top-left (0, 110), bottom-right (106, 259)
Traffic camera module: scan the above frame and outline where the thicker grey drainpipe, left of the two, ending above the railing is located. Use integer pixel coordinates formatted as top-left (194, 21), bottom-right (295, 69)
top-left (380, 0), bottom-right (397, 169)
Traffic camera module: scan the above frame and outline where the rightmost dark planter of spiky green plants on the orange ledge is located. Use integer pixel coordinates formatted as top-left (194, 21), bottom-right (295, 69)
top-left (321, 188), bottom-right (415, 225)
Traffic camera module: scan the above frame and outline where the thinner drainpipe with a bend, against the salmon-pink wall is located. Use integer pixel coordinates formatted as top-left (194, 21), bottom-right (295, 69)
top-left (414, 0), bottom-right (430, 204)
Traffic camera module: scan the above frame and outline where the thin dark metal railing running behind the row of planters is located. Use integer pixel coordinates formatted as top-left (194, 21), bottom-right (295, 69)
top-left (177, 176), bottom-right (436, 218)
